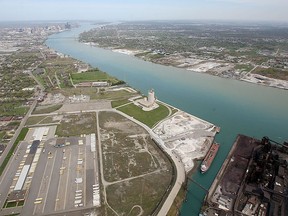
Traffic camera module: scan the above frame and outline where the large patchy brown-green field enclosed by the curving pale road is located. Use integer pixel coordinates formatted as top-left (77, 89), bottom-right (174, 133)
top-left (99, 112), bottom-right (173, 215)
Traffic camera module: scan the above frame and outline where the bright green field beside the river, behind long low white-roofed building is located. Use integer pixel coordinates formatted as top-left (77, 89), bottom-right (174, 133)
top-left (71, 69), bottom-right (119, 84)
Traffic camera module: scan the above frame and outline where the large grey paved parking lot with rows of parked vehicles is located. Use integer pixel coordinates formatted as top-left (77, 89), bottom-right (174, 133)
top-left (1, 127), bottom-right (99, 216)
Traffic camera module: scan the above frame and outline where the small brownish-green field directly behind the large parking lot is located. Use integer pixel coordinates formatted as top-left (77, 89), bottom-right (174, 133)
top-left (56, 113), bottom-right (96, 137)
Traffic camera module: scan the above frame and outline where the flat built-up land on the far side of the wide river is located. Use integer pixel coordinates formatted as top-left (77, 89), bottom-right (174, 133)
top-left (79, 21), bottom-right (288, 89)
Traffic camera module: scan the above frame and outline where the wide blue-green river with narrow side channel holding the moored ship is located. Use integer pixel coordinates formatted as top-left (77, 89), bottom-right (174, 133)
top-left (46, 23), bottom-right (288, 216)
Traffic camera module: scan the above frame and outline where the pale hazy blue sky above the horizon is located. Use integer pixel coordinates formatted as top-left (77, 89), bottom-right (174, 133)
top-left (0, 0), bottom-right (288, 22)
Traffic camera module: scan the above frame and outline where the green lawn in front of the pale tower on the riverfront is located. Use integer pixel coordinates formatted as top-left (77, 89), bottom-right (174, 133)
top-left (118, 104), bottom-right (169, 128)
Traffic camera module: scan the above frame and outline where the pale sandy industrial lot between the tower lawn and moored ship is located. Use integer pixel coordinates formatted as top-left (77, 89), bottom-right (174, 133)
top-left (154, 111), bottom-right (219, 173)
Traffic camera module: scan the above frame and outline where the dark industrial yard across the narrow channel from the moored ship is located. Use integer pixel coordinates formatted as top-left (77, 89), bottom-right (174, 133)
top-left (203, 135), bottom-right (288, 216)
